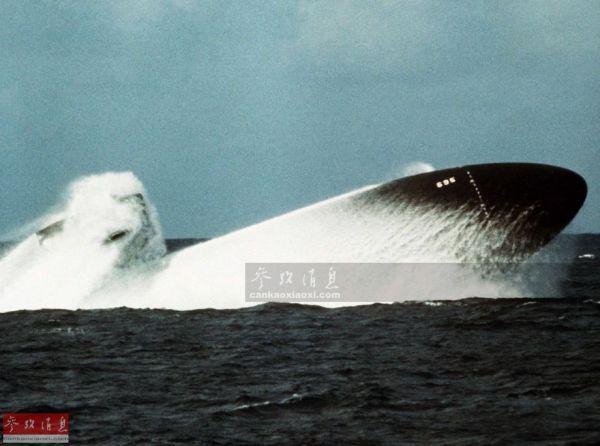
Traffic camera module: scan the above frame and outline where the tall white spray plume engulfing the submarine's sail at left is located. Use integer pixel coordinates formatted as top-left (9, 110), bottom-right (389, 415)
top-left (0, 172), bottom-right (165, 311)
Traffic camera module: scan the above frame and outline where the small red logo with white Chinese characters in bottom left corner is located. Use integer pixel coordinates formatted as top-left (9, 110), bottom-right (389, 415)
top-left (2, 413), bottom-right (69, 444)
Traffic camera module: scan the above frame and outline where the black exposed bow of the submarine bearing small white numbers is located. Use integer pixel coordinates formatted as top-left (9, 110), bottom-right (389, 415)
top-left (357, 163), bottom-right (587, 260)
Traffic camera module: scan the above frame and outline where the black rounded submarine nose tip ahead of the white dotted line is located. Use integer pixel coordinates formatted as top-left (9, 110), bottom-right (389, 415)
top-left (465, 163), bottom-right (587, 254)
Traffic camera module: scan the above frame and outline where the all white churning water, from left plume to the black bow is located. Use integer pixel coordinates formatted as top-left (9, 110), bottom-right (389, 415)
top-left (0, 173), bottom-right (540, 311)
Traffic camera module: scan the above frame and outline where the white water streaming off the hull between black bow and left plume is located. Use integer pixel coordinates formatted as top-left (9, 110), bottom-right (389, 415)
top-left (150, 193), bottom-right (524, 309)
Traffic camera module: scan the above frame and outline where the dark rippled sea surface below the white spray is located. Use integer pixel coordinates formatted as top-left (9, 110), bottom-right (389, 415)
top-left (0, 234), bottom-right (600, 445)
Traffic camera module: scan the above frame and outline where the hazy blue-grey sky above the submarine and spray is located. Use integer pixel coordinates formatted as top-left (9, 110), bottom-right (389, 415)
top-left (0, 0), bottom-right (600, 237)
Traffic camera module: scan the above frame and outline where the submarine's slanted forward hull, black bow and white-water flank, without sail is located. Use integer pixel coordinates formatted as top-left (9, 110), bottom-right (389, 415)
top-left (152, 163), bottom-right (587, 309)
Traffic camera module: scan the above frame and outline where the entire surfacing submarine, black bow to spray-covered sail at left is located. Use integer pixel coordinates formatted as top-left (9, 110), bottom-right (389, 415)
top-left (0, 163), bottom-right (587, 310)
